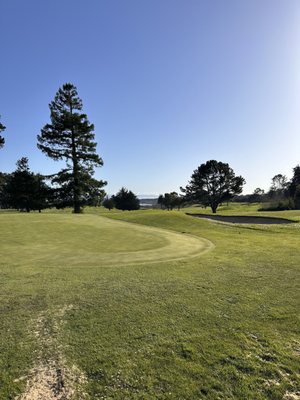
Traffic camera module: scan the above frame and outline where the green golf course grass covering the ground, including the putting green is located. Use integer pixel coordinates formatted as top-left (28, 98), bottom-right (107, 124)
top-left (0, 205), bottom-right (300, 400)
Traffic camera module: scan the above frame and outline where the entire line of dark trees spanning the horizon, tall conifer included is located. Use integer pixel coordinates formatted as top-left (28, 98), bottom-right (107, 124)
top-left (0, 83), bottom-right (300, 213)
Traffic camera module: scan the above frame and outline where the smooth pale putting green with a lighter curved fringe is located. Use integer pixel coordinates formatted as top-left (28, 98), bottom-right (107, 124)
top-left (0, 214), bottom-right (213, 267)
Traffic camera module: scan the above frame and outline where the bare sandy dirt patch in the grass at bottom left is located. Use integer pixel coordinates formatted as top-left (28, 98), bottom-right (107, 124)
top-left (15, 306), bottom-right (86, 400)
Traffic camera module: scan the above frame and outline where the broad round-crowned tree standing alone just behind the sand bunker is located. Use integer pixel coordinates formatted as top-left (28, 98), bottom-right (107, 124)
top-left (181, 160), bottom-right (245, 213)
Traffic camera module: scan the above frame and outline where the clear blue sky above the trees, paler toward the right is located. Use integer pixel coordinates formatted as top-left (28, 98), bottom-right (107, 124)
top-left (0, 0), bottom-right (300, 194)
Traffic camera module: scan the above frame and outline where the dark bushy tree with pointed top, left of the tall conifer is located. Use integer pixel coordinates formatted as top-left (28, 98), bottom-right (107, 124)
top-left (3, 157), bottom-right (50, 212)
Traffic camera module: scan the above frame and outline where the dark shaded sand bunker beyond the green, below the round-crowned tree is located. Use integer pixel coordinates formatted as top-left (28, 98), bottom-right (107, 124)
top-left (187, 213), bottom-right (296, 225)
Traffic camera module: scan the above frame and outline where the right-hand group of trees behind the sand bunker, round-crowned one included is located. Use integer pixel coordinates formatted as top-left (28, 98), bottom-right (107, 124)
top-left (170, 160), bottom-right (300, 213)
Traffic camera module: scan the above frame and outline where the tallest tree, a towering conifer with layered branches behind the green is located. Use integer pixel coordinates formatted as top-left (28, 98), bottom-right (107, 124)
top-left (37, 83), bottom-right (106, 213)
